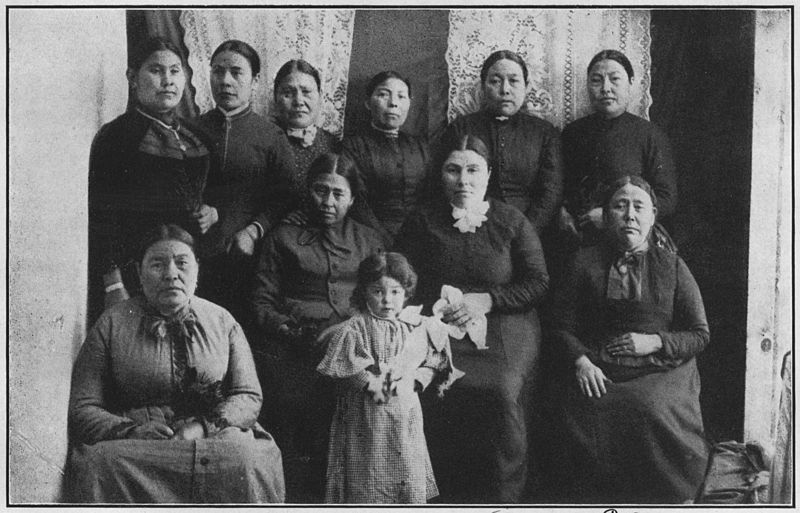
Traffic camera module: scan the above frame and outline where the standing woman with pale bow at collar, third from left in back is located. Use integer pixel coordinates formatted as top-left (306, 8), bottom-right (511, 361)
top-left (274, 59), bottom-right (339, 210)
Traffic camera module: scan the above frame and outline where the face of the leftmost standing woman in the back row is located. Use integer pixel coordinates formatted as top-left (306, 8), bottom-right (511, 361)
top-left (128, 50), bottom-right (186, 114)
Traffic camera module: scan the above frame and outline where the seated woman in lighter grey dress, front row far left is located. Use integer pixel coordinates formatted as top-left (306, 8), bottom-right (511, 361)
top-left (69, 225), bottom-right (284, 503)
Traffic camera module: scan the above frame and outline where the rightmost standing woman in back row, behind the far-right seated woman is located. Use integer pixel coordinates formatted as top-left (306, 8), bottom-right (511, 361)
top-left (560, 50), bottom-right (678, 249)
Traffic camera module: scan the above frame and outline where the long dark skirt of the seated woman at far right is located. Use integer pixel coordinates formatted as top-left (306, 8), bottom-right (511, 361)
top-left (562, 359), bottom-right (708, 504)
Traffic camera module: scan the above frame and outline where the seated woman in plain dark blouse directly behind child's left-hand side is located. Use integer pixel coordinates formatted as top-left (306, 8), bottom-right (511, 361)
top-left (251, 153), bottom-right (383, 502)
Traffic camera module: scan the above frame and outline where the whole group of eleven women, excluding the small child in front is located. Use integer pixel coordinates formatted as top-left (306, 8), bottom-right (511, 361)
top-left (69, 38), bottom-right (709, 503)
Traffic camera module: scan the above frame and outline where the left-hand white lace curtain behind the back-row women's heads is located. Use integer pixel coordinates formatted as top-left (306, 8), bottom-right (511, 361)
top-left (180, 9), bottom-right (355, 134)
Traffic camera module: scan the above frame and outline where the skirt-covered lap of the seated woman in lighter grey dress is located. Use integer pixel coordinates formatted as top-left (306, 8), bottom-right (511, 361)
top-left (70, 427), bottom-right (285, 503)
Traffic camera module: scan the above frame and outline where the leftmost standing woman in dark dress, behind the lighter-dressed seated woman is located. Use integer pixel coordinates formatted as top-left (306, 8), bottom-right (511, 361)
top-left (89, 37), bottom-right (218, 321)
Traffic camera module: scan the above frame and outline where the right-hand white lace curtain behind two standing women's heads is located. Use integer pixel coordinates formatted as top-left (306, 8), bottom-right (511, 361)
top-left (446, 9), bottom-right (652, 128)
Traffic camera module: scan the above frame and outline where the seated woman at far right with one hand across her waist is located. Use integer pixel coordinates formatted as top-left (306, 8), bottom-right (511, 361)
top-left (552, 176), bottom-right (709, 503)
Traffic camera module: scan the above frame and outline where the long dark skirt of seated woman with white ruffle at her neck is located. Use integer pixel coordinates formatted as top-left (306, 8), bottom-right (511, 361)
top-left (422, 311), bottom-right (541, 504)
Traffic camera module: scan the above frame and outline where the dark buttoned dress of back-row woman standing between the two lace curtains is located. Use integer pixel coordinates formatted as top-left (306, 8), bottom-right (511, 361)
top-left (342, 127), bottom-right (428, 237)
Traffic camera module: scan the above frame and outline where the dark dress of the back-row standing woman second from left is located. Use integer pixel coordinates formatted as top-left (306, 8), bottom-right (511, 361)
top-left (198, 106), bottom-right (292, 325)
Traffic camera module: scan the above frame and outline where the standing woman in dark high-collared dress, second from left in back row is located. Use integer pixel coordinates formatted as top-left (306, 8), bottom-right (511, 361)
top-left (199, 39), bottom-right (291, 323)
